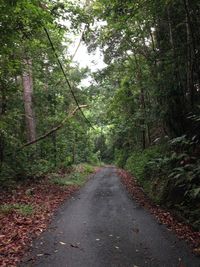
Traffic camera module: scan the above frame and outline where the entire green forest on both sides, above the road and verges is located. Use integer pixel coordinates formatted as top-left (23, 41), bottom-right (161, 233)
top-left (0, 0), bottom-right (200, 266)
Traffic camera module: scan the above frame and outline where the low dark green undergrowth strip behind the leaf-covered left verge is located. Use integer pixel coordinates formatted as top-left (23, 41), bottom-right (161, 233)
top-left (0, 152), bottom-right (100, 188)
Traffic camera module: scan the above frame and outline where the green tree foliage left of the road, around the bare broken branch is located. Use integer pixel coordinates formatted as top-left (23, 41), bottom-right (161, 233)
top-left (0, 0), bottom-right (96, 185)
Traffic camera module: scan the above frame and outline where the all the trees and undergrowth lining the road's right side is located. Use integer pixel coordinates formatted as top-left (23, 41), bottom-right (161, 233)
top-left (80, 0), bottom-right (200, 230)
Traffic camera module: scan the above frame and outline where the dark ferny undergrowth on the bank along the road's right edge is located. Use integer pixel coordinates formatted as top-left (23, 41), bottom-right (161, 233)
top-left (118, 136), bottom-right (200, 230)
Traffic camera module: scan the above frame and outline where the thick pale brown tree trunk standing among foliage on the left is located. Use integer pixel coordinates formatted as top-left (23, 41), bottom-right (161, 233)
top-left (22, 58), bottom-right (36, 142)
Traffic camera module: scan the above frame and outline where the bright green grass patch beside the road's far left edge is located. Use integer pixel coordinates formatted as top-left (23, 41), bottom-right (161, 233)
top-left (50, 164), bottom-right (94, 186)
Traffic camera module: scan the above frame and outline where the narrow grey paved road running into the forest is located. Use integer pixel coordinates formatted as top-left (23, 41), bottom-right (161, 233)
top-left (21, 168), bottom-right (200, 267)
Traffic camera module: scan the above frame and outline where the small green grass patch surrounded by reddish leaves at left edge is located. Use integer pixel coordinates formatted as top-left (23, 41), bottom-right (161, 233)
top-left (0, 203), bottom-right (34, 216)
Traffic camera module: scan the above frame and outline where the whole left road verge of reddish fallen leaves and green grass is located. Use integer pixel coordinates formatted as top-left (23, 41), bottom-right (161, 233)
top-left (0, 164), bottom-right (97, 266)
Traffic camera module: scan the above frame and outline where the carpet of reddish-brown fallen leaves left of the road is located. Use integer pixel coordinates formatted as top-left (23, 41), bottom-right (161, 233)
top-left (0, 178), bottom-right (79, 267)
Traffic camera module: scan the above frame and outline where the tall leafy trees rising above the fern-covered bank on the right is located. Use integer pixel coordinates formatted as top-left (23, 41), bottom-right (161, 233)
top-left (86, 0), bottom-right (200, 157)
